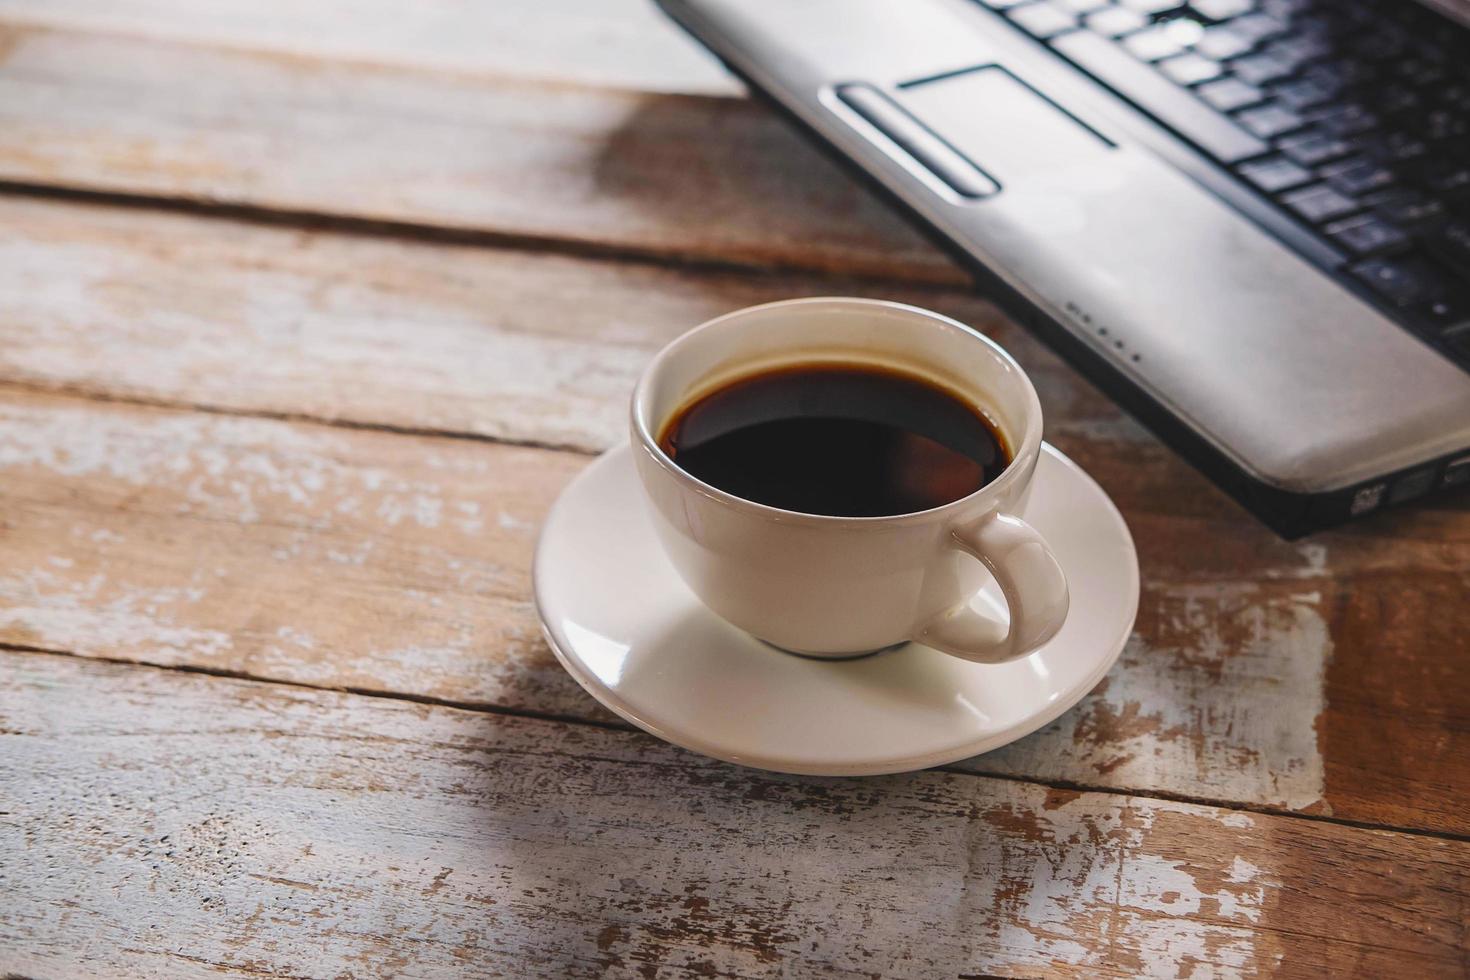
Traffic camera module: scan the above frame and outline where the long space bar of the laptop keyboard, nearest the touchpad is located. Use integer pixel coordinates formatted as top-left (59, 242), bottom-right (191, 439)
top-left (1051, 31), bottom-right (1270, 165)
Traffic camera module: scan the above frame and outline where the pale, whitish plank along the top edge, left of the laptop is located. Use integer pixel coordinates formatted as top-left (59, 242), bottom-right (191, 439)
top-left (0, 0), bottom-right (741, 96)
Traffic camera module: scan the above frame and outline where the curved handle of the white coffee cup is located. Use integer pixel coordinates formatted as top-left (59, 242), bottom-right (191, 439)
top-left (914, 514), bottom-right (1070, 664)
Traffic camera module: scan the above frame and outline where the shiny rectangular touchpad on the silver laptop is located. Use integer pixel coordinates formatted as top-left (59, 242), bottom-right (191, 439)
top-left (895, 65), bottom-right (1113, 187)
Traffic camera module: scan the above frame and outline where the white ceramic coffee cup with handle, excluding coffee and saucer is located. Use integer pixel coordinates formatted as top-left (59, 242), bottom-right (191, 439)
top-left (632, 298), bottom-right (1067, 664)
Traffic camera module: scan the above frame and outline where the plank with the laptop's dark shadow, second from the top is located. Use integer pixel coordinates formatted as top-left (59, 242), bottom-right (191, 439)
top-left (0, 23), bottom-right (967, 284)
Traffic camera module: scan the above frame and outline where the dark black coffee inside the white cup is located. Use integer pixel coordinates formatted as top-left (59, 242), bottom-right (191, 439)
top-left (659, 364), bottom-right (1010, 517)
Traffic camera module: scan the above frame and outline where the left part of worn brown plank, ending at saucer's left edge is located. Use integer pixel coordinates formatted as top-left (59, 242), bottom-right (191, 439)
top-left (0, 387), bottom-right (599, 718)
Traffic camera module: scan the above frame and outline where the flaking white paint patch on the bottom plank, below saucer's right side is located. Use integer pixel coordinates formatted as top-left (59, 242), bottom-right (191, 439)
top-left (931, 789), bottom-right (1299, 977)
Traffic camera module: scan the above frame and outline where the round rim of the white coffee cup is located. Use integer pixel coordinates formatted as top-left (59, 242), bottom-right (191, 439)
top-left (629, 297), bottom-right (1042, 527)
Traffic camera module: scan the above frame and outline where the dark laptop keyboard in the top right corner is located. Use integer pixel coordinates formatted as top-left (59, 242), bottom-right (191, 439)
top-left (980, 0), bottom-right (1470, 367)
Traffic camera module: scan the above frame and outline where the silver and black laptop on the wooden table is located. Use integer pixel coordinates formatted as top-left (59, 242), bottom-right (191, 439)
top-left (659, 0), bottom-right (1470, 538)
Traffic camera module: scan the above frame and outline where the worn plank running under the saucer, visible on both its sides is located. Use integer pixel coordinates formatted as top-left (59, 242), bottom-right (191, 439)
top-left (0, 376), bottom-right (1470, 833)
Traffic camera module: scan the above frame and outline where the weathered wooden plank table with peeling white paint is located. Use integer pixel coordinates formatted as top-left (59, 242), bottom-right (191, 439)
top-left (0, 0), bottom-right (1470, 977)
